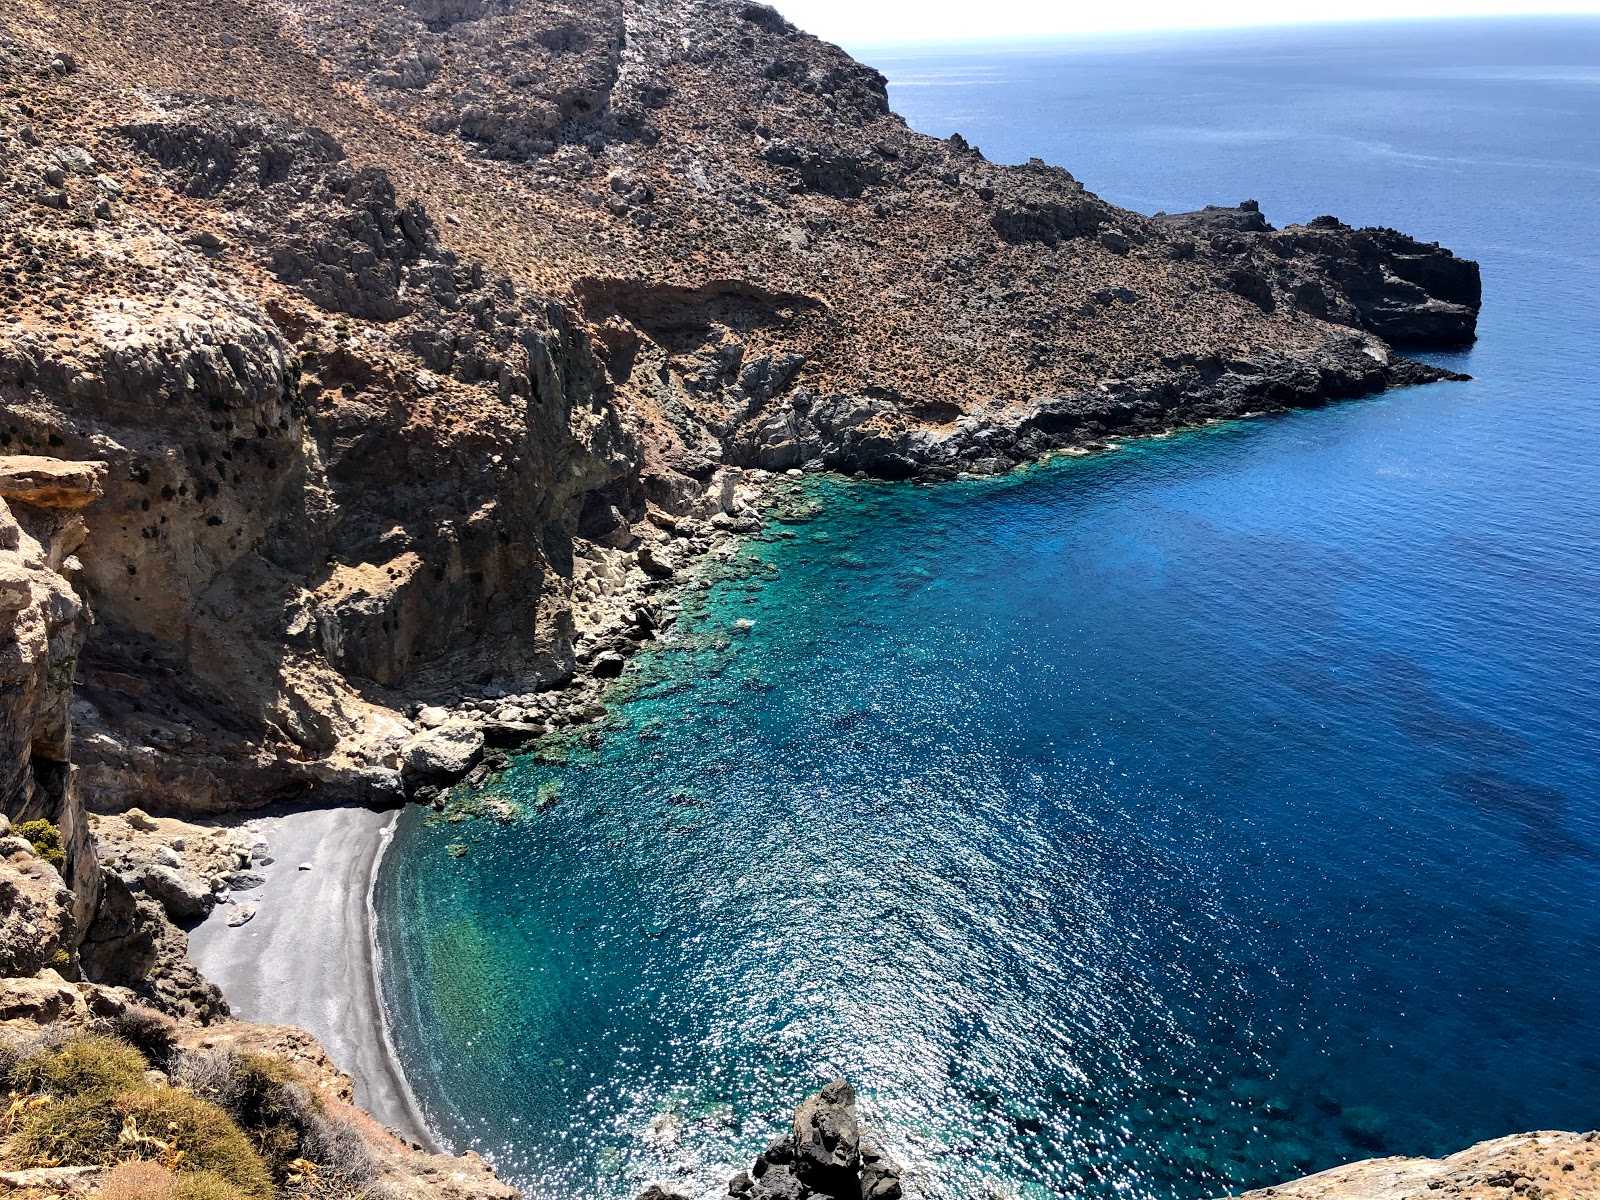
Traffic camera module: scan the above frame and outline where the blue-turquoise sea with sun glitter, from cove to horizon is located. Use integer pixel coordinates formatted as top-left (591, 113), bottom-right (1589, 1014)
top-left (378, 21), bottom-right (1600, 1200)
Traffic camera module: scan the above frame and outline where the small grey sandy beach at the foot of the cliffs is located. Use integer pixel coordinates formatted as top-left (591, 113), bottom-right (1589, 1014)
top-left (189, 805), bottom-right (443, 1154)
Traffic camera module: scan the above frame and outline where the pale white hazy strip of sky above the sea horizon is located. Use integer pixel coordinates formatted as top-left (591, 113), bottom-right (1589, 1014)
top-left (771, 0), bottom-right (1600, 45)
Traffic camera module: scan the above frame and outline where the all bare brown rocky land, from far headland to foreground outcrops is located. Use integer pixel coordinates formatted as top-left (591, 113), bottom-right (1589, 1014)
top-left (0, 0), bottom-right (1574, 1200)
